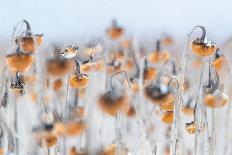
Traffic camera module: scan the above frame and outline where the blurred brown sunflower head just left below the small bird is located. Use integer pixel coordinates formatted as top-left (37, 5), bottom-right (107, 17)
top-left (47, 59), bottom-right (74, 77)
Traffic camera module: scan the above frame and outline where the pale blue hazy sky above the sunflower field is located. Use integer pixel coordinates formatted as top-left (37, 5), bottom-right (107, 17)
top-left (0, 0), bottom-right (232, 44)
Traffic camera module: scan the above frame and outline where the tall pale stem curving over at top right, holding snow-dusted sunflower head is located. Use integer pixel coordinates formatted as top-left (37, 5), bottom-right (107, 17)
top-left (171, 26), bottom-right (206, 155)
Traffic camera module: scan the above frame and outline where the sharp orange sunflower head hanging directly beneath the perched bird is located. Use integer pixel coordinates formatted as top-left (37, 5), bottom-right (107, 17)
top-left (69, 74), bottom-right (89, 89)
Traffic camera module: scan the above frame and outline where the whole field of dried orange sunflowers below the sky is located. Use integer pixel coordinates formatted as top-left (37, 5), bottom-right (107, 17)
top-left (0, 20), bottom-right (232, 155)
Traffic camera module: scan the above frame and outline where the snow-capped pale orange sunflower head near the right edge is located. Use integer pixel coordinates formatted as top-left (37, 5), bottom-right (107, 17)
top-left (204, 90), bottom-right (228, 108)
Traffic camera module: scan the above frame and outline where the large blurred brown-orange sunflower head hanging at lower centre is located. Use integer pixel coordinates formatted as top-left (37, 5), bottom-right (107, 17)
top-left (98, 92), bottom-right (128, 116)
